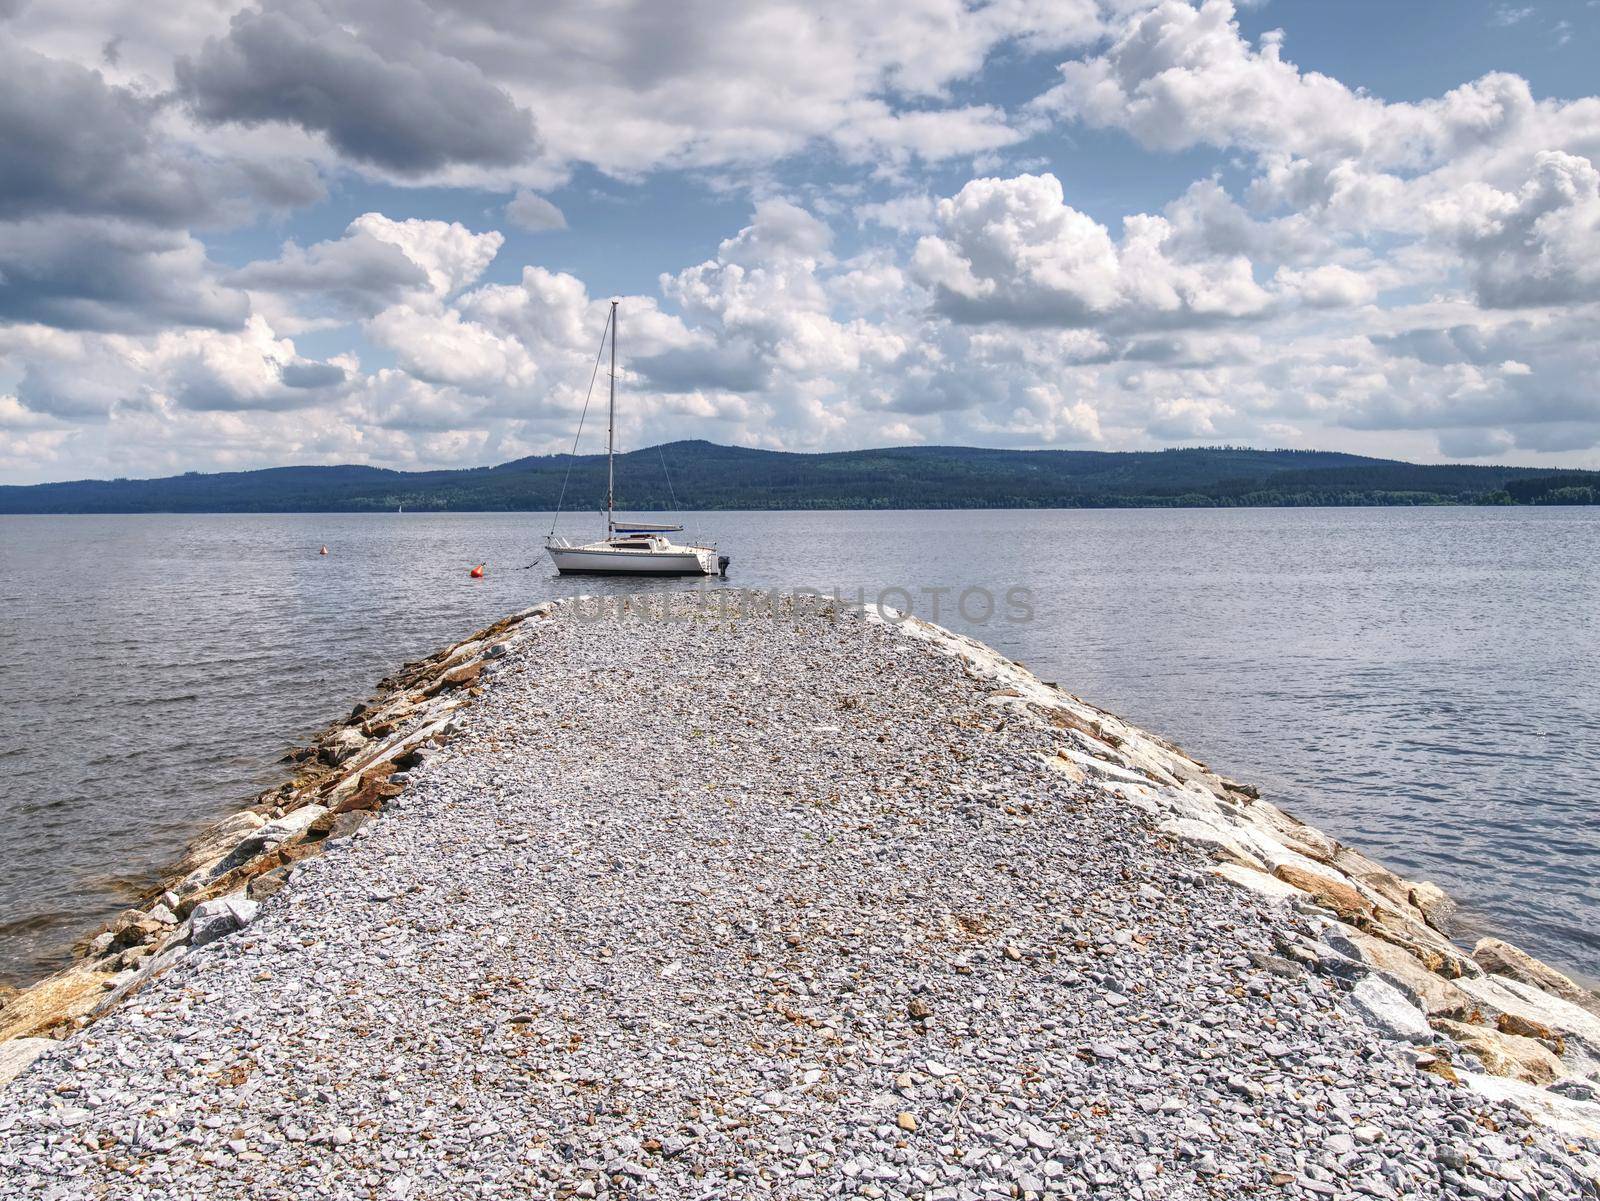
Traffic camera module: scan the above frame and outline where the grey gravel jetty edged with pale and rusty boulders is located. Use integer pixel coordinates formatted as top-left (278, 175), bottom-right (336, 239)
top-left (0, 592), bottom-right (1600, 1201)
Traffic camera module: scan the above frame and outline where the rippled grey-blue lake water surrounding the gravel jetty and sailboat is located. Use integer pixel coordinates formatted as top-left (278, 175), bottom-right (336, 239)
top-left (0, 509), bottom-right (1600, 980)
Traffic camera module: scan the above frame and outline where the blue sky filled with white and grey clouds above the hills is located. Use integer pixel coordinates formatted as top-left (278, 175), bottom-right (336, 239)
top-left (0, 0), bottom-right (1600, 483)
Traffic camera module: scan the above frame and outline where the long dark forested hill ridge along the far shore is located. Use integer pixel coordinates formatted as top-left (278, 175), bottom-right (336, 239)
top-left (0, 441), bottom-right (1600, 513)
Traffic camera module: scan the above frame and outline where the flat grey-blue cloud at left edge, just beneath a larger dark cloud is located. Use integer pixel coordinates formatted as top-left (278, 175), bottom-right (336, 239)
top-left (0, 217), bottom-right (250, 333)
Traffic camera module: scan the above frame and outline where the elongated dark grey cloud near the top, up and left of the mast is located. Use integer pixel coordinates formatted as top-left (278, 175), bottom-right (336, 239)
top-left (176, 3), bottom-right (538, 176)
